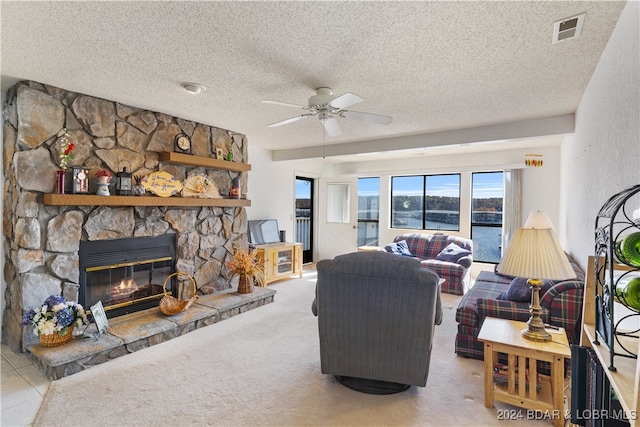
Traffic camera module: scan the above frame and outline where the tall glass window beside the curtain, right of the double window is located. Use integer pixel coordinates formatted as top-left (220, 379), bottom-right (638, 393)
top-left (471, 172), bottom-right (504, 263)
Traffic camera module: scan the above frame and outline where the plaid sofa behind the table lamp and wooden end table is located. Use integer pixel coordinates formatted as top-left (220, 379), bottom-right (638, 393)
top-left (456, 257), bottom-right (584, 360)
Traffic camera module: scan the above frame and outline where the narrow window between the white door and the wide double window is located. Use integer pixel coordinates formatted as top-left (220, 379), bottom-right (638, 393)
top-left (358, 178), bottom-right (380, 246)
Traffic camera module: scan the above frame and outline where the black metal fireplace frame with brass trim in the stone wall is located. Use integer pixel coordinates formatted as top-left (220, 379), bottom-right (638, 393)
top-left (78, 234), bottom-right (176, 318)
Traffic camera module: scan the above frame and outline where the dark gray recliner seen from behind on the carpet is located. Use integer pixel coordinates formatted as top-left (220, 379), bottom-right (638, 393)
top-left (312, 252), bottom-right (442, 394)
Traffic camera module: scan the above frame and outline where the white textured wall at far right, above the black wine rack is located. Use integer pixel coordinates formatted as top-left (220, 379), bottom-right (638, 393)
top-left (560, 1), bottom-right (640, 267)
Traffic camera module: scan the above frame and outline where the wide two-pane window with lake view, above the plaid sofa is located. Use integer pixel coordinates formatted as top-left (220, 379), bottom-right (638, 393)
top-left (391, 174), bottom-right (460, 231)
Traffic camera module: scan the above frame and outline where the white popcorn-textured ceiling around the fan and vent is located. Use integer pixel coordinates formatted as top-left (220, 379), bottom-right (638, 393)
top-left (0, 1), bottom-right (624, 160)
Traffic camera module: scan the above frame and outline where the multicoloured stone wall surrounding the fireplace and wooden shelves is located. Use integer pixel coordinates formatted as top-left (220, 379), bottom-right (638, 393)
top-left (2, 81), bottom-right (248, 352)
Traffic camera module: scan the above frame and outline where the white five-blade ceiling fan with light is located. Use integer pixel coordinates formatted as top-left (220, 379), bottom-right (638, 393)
top-left (262, 87), bottom-right (392, 136)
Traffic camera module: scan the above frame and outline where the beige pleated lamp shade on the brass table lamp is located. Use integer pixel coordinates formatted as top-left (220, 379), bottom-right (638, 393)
top-left (497, 212), bottom-right (576, 280)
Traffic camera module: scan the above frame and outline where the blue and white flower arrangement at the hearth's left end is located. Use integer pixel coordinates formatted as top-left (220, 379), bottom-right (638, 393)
top-left (22, 295), bottom-right (89, 336)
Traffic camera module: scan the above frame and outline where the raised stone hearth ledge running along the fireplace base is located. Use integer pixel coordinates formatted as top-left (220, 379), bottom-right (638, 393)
top-left (27, 288), bottom-right (276, 380)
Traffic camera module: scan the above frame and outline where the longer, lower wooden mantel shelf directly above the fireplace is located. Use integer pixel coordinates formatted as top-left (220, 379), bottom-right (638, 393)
top-left (43, 193), bottom-right (251, 208)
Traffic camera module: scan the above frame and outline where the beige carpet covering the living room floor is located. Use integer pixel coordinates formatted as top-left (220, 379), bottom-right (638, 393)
top-left (34, 272), bottom-right (552, 427)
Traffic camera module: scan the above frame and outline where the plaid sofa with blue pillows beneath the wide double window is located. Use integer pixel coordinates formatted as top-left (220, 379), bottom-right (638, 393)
top-left (393, 233), bottom-right (473, 295)
